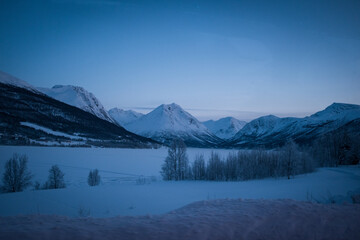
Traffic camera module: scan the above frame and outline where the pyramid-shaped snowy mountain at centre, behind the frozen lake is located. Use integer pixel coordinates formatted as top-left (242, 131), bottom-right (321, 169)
top-left (125, 103), bottom-right (222, 147)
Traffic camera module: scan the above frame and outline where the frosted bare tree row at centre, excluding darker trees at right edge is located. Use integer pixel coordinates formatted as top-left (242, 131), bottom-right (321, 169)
top-left (161, 140), bottom-right (316, 181)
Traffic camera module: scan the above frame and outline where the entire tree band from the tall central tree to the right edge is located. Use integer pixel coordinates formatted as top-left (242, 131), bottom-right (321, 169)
top-left (161, 130), bottom-right (360, 181)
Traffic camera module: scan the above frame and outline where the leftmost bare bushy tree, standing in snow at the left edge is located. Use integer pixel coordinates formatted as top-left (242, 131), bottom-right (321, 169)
top-left (2, 154), bottom-right (32, 192)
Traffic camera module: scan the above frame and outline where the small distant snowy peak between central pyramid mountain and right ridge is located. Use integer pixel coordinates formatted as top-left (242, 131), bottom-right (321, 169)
top-left (203, 117), bottom-right (246, 139)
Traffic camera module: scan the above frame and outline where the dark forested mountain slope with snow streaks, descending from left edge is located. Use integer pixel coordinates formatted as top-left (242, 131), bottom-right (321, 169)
top-left (0, 70), bottom-right (158, 148)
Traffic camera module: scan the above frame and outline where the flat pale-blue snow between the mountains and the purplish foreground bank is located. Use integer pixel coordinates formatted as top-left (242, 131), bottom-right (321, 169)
top-left (0, 146), bottom-right (360, 217)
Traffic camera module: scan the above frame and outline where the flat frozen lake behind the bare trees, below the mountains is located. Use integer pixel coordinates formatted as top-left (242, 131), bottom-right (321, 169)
top-left (0, 146), bottom-right (232, 187)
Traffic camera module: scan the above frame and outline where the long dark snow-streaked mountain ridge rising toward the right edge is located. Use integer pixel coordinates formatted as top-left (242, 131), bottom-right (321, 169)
top-left (230, 103), bottom-right (360, 147)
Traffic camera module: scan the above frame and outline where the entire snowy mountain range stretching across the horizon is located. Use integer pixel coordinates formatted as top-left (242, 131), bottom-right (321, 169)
top-left (0, 72), bottom-right (360, 148)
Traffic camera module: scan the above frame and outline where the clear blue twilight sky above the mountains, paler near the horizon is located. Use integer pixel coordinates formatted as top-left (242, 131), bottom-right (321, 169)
top-left (0, 0), bottom-right (360, 120)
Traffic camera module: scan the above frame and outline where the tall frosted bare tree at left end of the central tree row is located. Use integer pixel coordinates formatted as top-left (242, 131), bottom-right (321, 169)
top-left (161, 140), bottom-right (189, 181)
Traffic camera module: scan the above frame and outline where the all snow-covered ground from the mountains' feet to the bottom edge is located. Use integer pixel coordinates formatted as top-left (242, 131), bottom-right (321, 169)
top-left (0, 146), bottom-right (360, 239)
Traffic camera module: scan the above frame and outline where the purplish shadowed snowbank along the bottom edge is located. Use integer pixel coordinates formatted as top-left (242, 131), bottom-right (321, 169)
top-left (0, 199), bottom-right (360, 240)
